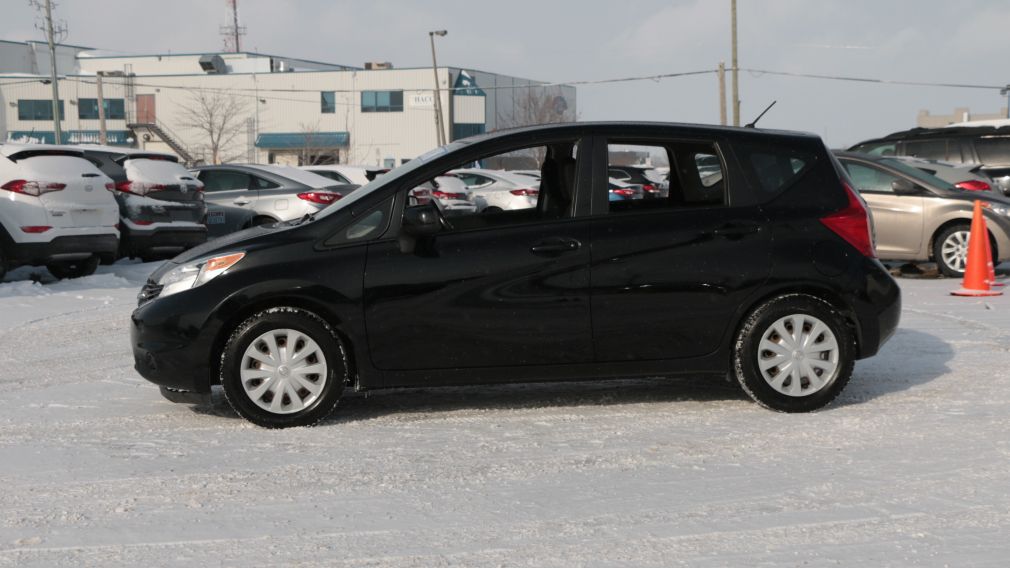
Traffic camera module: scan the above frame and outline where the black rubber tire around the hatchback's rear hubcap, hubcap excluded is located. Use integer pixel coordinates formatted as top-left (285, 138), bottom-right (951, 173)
top-left (733, 294), bottom-right (855, 412)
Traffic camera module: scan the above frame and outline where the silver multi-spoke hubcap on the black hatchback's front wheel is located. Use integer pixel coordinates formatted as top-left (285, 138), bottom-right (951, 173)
top-left (239, 329), bottom-right (326, 414)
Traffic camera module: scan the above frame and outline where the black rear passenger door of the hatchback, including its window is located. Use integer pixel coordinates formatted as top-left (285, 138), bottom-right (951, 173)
top-left (590, 136), bottom-right (771, 362)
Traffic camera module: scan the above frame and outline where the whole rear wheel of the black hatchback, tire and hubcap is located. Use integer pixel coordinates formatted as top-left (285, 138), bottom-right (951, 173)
top-left (733, 294), bottom-right (855, 412)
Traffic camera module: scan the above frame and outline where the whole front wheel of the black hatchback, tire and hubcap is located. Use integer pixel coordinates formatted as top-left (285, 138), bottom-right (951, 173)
top-left (220, 307), bottom-right (347, 428)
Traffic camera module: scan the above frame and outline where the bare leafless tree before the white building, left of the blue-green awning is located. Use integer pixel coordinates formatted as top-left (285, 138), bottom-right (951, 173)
top-left (180, 89), bottom-right (249, 164)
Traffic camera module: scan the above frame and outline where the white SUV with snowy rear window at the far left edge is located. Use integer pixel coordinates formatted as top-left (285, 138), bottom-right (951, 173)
top-left (0, 145), bottom-right (119, 278)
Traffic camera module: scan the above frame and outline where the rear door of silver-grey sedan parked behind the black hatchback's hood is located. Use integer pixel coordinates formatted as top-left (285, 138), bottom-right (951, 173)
top-left (197, 169), bottom-right (258, 236)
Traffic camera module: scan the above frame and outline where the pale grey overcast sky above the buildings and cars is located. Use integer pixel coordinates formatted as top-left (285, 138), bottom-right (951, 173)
top-left (0, 0), bottom-right (1010, 147)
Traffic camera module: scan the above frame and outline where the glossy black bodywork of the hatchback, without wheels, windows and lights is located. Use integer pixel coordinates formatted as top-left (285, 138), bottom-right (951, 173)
top-left (132, 123), bottom-right (900, 392)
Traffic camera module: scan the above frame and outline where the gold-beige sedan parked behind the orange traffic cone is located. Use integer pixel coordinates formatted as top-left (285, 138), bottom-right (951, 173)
top-left (834, 152), bottom-right (1010, 277)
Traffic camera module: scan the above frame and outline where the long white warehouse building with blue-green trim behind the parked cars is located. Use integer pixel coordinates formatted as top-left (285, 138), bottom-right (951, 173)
top-left (0, 41), bottom-right (576, 167)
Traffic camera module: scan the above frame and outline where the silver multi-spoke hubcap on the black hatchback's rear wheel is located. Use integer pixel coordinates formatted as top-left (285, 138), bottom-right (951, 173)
top-left (758, 313), bottom-right (838, 396)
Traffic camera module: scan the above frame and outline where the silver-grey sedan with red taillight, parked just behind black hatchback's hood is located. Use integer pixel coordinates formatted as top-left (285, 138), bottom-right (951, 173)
top-left (192, 164), bottom-right (359, 236)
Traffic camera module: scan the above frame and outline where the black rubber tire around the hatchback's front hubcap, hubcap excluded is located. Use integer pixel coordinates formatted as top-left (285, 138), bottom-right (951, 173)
top-left (220, 307), bottom-right (348, 429)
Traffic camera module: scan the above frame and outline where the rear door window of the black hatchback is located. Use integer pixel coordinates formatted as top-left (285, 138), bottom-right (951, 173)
top-left (607, 139), bottom-right (726, 213)
